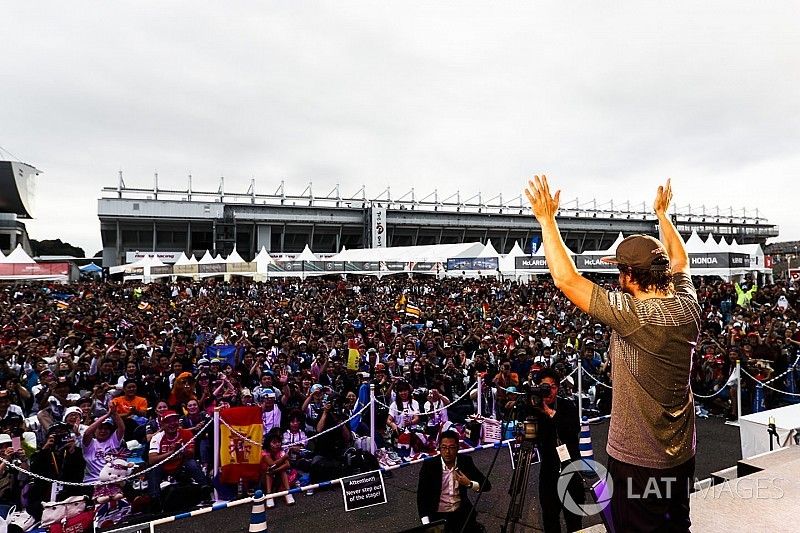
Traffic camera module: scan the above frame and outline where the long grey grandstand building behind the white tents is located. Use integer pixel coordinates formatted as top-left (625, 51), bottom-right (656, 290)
top-left (98, 172), bottom-right (778, 266)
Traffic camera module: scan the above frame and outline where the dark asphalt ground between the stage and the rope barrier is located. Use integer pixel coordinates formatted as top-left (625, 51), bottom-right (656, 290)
top-left (142, 418), bottom-right (741, 533)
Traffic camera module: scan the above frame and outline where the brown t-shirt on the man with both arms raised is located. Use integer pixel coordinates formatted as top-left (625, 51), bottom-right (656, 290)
top-left (589, 274), bottom-right (700, 468)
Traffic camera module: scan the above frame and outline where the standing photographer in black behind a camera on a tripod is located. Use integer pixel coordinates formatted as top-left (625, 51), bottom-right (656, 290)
top-left (520, 369), bottom-right (584, 533)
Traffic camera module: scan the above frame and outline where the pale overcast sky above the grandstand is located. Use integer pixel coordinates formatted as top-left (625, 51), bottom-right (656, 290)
top-left (0, 0), bottom-right (800, 254)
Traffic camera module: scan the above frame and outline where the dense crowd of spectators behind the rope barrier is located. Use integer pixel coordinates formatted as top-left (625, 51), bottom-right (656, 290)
top-left (0, 276), bottom-right (800, 517)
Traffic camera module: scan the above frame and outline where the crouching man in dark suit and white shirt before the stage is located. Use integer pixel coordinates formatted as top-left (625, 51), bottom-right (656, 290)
top-left (417, 431), bottom-right (492, 533)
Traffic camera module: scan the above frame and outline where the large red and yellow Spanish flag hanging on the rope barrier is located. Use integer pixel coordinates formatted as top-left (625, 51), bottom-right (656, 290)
top-left (219, 407), bottom-right (264, 484)
